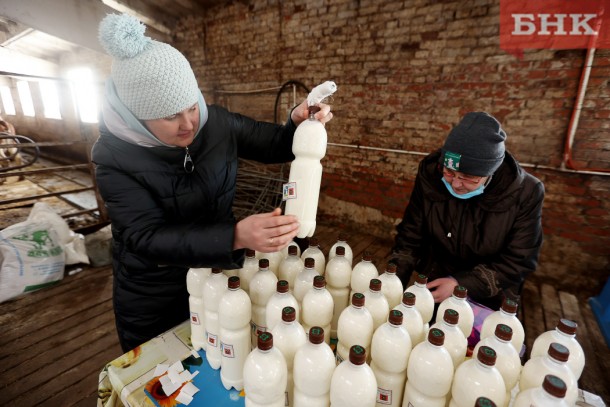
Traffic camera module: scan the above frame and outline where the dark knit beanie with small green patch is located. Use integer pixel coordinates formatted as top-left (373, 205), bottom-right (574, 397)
top-left (442, 112), bottom-right (506, 177)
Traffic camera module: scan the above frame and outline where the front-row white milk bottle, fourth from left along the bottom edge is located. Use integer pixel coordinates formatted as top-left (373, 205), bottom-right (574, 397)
top-left (402, 328), bottom-right (454, 407)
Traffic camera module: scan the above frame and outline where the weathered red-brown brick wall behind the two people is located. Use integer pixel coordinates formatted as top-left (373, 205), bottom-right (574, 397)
top-left (175, 0), bottom-right (610, 297)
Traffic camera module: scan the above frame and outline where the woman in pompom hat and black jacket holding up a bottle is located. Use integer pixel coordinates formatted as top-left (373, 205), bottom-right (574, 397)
top-left (92, 14), bottom-right (332, 351)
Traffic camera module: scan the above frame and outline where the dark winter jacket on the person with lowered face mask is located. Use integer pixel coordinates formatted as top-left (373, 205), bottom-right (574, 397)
top-left (393, 150), bottom-right (544, 309)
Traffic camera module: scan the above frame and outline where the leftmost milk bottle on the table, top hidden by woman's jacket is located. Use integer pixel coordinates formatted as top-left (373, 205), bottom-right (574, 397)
top-left (186, 268), bottom-right (212, 351)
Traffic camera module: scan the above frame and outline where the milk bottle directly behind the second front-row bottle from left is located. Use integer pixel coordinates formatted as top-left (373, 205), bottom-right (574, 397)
top-left (302, 276), bottom-right (335, 344)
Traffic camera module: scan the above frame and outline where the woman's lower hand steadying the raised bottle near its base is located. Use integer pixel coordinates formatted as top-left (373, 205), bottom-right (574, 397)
top-left (233, 208), bottom-right (299, 253)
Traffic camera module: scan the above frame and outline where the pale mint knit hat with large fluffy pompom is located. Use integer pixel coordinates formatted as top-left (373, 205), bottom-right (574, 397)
top-left (99, 14), bottom-right (201, 120)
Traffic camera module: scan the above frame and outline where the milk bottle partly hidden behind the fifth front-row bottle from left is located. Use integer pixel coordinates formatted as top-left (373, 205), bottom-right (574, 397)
top-left (473, 324), bottom-right (521, 402)
